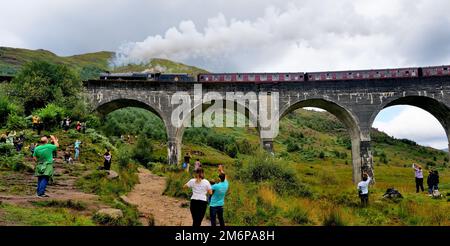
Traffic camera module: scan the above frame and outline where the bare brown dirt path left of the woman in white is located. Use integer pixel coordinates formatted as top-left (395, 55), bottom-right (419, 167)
top-left (122, 168), bottom-right (209, 226)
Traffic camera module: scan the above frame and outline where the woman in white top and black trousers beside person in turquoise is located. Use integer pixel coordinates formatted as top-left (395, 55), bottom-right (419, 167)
top-left (183, 168), bottom-right (212, 226)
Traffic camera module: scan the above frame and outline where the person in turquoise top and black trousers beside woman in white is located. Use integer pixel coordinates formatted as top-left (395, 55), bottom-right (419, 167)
top-left (209, 173), bottom-right (228, 226)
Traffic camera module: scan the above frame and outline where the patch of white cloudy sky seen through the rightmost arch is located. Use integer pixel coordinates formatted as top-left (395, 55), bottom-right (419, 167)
top-left (373, 106), bottom-right (448, 149)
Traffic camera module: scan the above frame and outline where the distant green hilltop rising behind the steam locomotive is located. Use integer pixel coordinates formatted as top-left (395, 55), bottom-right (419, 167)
top-left (0, 47), bottom-right (206, 80)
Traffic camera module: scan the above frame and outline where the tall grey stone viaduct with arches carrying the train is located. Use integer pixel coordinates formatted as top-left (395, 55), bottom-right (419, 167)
top-left (84, 77), bottom-right (450, 182)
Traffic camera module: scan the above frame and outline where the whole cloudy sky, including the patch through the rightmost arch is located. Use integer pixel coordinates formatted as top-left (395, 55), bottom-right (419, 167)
top-left (0, 0), bottom-right (450, 148)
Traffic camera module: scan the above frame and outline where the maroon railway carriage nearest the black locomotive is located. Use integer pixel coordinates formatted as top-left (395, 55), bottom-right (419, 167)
top-left (198, 73), bottom-right (305, 84)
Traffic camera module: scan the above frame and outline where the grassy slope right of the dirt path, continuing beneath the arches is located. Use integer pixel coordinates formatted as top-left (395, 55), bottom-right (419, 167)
top-left (105, 106), bottom-right (450, 225)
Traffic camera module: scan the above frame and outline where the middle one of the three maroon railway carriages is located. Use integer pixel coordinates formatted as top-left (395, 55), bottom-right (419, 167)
top-left (307, 68), bottom-right (419, 81)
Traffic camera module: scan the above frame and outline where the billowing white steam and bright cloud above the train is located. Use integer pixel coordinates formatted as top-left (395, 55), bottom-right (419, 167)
top-left (110, 0), bottom-right (450, 71)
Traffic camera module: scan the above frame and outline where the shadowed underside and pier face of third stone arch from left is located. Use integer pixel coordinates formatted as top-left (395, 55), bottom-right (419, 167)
top-left (280, 98), bottom-right (364, 182)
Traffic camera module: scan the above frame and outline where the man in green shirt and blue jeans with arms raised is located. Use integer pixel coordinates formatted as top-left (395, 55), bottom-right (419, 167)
top-left (33, 136), bottom-right (59, 197)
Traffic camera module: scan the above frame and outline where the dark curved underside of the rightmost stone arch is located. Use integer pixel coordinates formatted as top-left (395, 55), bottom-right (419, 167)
top-left (369, 96), bottom-right (450, 160)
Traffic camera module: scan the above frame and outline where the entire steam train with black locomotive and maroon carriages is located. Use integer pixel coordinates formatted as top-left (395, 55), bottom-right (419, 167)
top-left (100, 65), bottom-right (450, 84)
